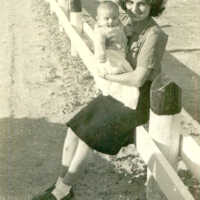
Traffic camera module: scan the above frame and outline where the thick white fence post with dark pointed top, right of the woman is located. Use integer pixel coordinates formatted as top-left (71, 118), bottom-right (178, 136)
top-left (146, 76), bottom-right (181, 200)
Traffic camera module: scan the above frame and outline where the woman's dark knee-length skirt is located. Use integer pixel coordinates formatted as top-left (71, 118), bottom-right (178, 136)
top-left (66, 82), bottom-right (151, 155)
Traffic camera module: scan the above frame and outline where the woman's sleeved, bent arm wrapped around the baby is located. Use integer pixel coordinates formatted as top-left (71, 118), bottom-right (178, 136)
top-left (105, 28), bottom-right (167, 87)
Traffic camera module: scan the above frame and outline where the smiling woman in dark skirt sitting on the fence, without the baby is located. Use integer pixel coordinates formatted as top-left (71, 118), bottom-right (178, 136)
top-left (33, 0), bottom-right (167, 200)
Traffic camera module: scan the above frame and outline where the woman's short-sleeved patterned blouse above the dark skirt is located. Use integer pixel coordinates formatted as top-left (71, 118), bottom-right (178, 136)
top-left (120, 1), bottom-right (168, 80)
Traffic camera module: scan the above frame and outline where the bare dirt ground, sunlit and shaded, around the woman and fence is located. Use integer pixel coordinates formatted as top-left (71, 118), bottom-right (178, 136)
top-left (0, 0), bottom-right (200, 200)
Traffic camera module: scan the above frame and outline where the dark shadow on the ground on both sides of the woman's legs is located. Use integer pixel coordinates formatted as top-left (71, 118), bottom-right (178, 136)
top-left (0, 118), bottom-right (145, 200)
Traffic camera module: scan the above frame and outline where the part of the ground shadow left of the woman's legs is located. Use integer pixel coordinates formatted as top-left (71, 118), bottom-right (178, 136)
top-left (0, 118), bottom-right (65, 196)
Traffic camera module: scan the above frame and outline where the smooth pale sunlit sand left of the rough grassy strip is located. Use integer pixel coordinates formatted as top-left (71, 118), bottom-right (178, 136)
top-left (1, 0), bottom-right (69, 118)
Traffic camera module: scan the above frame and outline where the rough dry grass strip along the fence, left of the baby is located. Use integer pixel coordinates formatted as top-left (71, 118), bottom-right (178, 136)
top-left (38, 0), bottom-right (98, 113)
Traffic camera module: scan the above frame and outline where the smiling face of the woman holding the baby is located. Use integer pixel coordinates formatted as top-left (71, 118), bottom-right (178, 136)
top-left (126, 0), bottom-right (151, 21)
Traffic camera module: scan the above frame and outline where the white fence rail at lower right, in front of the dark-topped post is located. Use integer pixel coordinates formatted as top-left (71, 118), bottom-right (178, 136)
top-left (136, 126), bottom-right (194, 200)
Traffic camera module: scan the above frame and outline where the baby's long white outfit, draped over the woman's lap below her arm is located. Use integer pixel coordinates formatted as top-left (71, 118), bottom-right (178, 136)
top-left (94, 24), bottom-right (139, 109)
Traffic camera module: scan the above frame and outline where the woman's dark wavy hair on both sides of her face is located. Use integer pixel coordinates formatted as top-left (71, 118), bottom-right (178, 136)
top-left (119, 0), bottom-right (165, 17)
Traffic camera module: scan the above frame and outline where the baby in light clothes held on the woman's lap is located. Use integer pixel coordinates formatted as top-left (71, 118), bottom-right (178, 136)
top-left (94, 1), bottom-right (139, 109)
